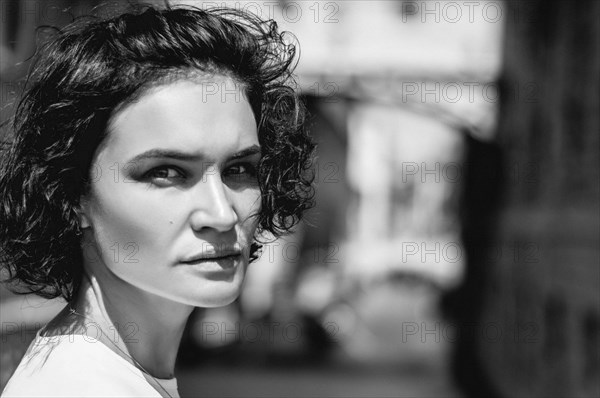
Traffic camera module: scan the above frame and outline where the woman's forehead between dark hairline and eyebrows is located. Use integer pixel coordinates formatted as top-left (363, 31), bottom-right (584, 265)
top-left (99, 76), bottom-right (258, 160)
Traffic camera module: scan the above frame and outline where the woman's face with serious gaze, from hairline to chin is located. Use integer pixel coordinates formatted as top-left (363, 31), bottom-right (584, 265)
top-left (81, 77), bottom-right (261, 307)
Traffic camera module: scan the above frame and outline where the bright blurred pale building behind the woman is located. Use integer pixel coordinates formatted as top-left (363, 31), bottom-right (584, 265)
top-left (237, 1), bottom-right (504, 370)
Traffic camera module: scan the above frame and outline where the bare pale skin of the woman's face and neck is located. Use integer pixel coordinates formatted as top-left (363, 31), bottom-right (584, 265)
top-left (39, 76), bottom-right (261, 386)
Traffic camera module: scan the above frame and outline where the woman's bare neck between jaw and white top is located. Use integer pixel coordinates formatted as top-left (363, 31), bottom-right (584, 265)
top-left (70, 267), bottom-right (193, 379)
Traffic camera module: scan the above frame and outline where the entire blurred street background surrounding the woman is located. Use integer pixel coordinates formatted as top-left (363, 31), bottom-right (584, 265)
top-left (0, 0), bottom-right (600, 397)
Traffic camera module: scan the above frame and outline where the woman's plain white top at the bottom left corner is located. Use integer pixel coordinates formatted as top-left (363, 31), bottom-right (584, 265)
top-left (0, 328), bottom-right (179, 398)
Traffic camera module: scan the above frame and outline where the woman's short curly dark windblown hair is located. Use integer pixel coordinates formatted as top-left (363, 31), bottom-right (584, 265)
top-left (0, 6), bottom-right (314, 301)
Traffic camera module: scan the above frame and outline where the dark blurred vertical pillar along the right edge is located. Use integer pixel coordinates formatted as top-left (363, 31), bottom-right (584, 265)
top-left (447, 0), bottom-right (600, 397)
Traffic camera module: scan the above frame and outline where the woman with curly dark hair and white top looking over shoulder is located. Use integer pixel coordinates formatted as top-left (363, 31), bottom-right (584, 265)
top-left (0, 3), bottom-right (313, 397)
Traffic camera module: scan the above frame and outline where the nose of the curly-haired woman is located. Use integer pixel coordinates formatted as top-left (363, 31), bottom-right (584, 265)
top-left (191, 173), bottom-right (238, 232)
